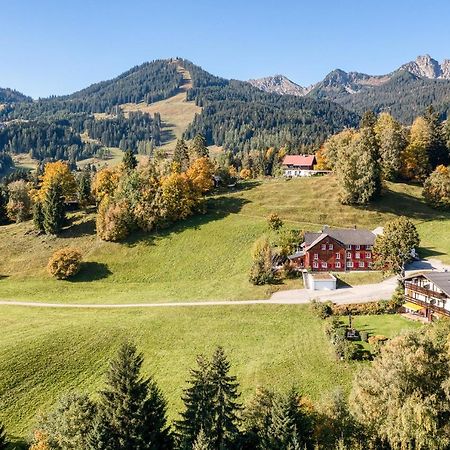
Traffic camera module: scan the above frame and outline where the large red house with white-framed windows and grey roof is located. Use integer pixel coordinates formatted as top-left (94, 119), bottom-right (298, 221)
top-left (289, 227), bottom-right (376, 272)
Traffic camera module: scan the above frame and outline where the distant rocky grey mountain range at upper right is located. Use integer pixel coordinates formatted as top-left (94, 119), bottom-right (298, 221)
top-left (249, 55), bottom-right (450, 123)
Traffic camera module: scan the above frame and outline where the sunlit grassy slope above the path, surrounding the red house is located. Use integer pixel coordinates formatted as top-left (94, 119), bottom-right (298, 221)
top-left (0, 177), bottom-right (450, 303)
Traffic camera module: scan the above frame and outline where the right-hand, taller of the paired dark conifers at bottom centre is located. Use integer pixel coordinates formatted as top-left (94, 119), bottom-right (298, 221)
top-left (210, 347), bottom-right (241, 449)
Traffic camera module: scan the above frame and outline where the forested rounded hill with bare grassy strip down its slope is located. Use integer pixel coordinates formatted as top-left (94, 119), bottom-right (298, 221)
top-left (0, 59), bottom-right (357, 164)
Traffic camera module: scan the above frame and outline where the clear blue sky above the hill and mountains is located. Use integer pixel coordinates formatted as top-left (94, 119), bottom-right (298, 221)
top-left (0, 0), bottom-right (450, 97)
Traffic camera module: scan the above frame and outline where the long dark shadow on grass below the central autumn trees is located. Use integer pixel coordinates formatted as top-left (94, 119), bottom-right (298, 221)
top-left (123, 196), bottom-right (249, 247)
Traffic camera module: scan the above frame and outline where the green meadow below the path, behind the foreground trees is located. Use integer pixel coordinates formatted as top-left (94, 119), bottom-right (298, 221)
top-left (0, 305), bottom-right (418, 437)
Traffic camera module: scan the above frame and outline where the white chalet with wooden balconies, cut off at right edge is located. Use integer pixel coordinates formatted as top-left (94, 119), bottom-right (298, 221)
top-left (403, 272), bottom-right (450, 320)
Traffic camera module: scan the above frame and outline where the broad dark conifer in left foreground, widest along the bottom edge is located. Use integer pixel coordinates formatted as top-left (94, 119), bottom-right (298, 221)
top-left (90, 343), bottom-right (173, 450)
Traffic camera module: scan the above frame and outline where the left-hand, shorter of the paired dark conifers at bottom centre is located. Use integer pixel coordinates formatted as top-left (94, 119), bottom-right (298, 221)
top-left (176, 356), bottom-right (213, 450)
